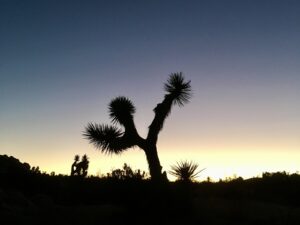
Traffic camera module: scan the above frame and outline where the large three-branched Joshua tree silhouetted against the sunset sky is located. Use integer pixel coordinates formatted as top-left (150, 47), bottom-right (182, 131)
top-left (84, 73), bottom-right (191, 181)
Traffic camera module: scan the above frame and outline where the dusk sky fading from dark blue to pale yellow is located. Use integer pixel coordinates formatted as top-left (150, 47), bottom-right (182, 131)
top-left (0, 0), bottom-right (300, 180)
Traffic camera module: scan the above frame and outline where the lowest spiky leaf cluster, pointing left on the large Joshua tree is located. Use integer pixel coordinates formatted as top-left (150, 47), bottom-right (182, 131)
top-left (84, 123), bottom-right (127, 154)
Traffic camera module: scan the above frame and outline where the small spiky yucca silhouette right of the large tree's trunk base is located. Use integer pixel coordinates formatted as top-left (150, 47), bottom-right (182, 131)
top-left (169, 161), bottom-right (204, 182)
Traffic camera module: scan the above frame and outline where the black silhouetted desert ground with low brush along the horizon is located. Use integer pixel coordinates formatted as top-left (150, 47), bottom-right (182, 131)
top-left (0, 155), bottom-right (300, 225)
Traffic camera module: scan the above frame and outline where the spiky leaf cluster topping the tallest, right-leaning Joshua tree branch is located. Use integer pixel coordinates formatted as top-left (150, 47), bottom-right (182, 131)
top-left (164, 72), bottom-right (192, 106)
